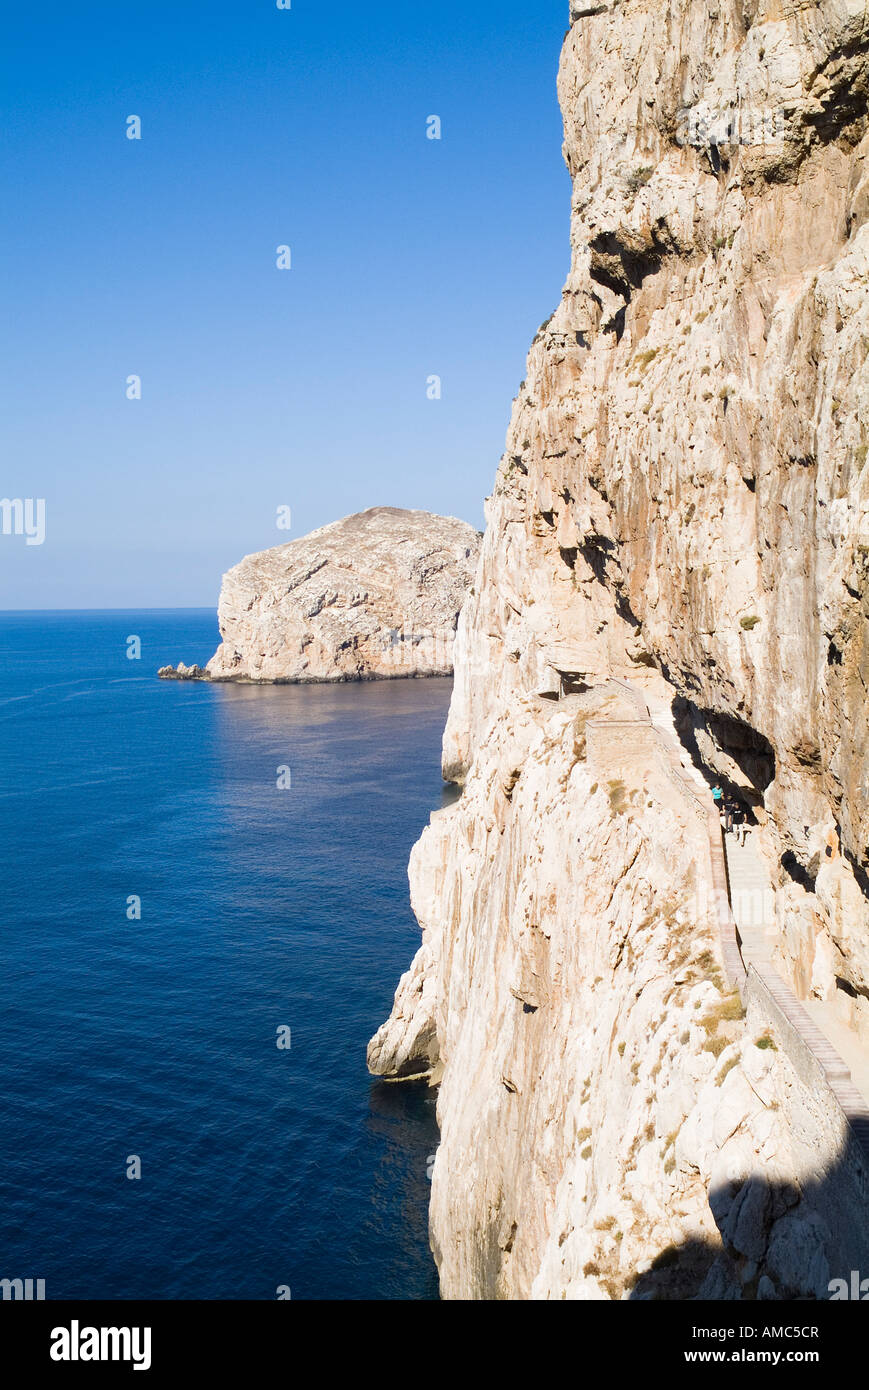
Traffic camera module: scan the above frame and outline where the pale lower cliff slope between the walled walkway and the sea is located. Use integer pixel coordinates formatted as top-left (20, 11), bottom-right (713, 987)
top-left (368, 687), bottom-right (866, 1300)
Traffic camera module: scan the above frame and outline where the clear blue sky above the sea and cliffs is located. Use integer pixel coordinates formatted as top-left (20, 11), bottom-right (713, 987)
top-left (0, 0), bottom-right (570, 609)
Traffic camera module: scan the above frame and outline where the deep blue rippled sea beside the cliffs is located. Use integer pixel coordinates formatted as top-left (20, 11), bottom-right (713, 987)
top-left (0, 610), bottom-right (449, 1300)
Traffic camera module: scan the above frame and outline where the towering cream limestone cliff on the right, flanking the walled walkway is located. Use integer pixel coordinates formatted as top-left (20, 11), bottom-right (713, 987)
top-left (370, 0), bottom-right (869, 1298)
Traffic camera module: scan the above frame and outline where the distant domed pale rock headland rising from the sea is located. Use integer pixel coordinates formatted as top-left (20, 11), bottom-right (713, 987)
top-left (207, 507), bottom-right (480, 681)
